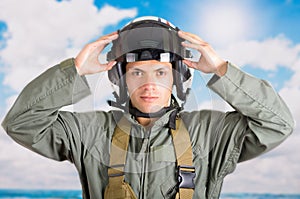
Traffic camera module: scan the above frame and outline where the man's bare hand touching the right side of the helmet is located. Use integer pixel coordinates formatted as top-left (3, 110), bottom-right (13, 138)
top-left (178, 31), bottom-right (227, 76)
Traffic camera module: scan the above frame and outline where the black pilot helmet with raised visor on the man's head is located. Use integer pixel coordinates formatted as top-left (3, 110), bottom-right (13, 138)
top-left (107, 17), bottom-right (192, 105)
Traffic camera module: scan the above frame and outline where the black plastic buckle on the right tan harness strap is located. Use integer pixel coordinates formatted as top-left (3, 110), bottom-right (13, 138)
top-left (178, 165), bottom-right (196, 189)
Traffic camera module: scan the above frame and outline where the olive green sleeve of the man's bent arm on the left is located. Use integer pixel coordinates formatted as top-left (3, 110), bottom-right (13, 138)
top-left (2, 59), bottom-right (90, 161)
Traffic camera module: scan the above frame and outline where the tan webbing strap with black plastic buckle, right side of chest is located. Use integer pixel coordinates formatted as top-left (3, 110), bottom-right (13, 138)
top-left (171, 119), bottom-right (195, 199)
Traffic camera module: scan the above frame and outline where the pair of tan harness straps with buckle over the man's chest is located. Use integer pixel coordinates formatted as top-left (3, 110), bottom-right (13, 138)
top-left (104, 117), bottom-right (195, 199)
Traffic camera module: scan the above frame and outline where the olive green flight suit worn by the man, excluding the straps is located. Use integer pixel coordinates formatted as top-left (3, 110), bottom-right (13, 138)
top-left (2, 59), bottom-right (294, 199)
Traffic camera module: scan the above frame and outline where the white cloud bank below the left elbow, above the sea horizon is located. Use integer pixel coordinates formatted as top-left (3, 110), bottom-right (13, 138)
top-left (0, 126), bottom-right (80, 189)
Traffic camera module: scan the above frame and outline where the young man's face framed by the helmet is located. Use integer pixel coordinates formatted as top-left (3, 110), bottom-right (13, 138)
top-left (126, 60), bottom-right (173, 113)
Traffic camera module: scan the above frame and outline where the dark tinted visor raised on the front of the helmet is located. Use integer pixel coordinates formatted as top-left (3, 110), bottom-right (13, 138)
top-left (107, 26), bottom-right (191, 62)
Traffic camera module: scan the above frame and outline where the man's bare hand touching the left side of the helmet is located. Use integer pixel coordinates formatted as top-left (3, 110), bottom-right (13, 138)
top-left (75, 32), bottom-right (119, 75)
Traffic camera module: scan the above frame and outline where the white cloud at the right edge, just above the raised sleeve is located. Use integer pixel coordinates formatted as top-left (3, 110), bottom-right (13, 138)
top-left (219, 35), bottom-right (300, 70)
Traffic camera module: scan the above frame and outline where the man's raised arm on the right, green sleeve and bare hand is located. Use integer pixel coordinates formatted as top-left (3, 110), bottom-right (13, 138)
top-left (179, 31), bottom-right (294, 161)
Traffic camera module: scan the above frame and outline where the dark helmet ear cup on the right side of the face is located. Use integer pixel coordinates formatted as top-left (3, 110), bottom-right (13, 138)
top-left (173, 60), bottom-right (191, 101)
